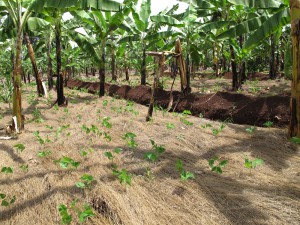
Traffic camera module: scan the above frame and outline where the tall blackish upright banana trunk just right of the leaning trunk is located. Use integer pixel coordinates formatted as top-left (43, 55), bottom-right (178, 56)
top-left (55, 21), bottom-right (65, 106)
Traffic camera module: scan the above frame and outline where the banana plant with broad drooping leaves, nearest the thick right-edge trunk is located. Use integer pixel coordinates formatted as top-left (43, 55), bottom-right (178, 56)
top-left (217, 0), bottom-right (289, 82)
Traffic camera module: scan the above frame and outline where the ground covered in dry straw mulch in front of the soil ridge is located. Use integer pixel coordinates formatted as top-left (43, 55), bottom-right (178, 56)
top-left (0, 81), bottom-right (300, 225)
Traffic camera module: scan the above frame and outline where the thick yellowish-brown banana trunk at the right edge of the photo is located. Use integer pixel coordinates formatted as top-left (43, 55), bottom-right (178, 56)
top-left (288, 0), bottom-right (300, 138)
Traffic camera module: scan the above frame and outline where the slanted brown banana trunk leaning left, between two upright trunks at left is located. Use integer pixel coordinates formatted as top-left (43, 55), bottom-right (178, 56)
top-left (24, 33), bottom-right (45, 96)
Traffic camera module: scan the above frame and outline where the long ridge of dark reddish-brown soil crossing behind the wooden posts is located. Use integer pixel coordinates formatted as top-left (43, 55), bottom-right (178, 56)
top-left (67, 80), bottom-right (289, 127)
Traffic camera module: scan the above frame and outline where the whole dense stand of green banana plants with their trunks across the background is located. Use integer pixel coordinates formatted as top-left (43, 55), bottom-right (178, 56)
top-left (0, 0), bottom-right (300, 137)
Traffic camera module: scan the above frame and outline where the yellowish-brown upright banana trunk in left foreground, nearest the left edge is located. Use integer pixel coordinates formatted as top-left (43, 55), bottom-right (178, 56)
top-left (12, 30), bottom-right (24, 131)
